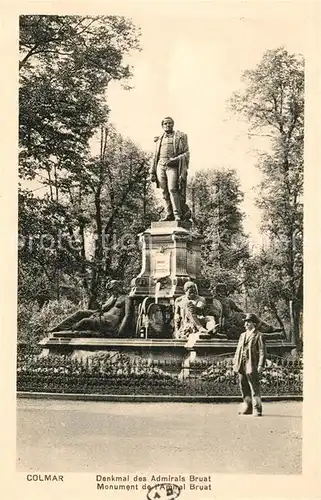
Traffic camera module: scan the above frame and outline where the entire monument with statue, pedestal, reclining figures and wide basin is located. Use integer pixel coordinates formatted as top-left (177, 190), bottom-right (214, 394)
top-left (40, 117), bottom-right (286, 362)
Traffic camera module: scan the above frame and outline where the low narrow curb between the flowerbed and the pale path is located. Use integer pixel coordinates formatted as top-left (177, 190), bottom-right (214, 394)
top-left (17, 391), bottom-right (303, 403)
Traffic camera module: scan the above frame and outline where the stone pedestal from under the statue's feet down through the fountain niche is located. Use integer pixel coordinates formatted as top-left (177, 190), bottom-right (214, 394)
top-left (129, 221), bottom-right (213, 339)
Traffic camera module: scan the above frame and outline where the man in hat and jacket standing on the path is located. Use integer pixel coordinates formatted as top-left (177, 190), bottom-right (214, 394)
top-left (233, 314), bottom-right (266, 417)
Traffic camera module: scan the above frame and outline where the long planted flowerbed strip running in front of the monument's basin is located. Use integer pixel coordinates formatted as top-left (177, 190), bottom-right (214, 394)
top-left (17, 353), bottom-right (303, 396)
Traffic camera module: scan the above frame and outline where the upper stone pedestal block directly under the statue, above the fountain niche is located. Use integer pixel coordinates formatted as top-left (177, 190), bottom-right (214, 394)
top-left (130, 221), bottom-right (212, 305)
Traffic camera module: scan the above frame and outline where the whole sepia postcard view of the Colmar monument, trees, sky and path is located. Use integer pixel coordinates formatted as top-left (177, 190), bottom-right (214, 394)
top-left (1, 1), bottom-right (320, 500)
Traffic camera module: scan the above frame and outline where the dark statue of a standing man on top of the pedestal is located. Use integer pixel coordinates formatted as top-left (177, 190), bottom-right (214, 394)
top-left (151, 116), bottom-right (191, 221)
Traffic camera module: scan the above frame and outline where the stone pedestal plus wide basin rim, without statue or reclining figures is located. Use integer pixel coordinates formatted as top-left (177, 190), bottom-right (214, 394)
top-left (35, 221), bottom-right (294, 373)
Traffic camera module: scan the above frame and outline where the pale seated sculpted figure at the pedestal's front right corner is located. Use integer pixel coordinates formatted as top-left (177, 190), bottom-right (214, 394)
top-left (174, 281), bottom-right (222, 348)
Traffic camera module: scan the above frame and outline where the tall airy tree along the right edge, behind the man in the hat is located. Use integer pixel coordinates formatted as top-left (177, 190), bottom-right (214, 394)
top-left (231, 48), bottom-right (304, 343)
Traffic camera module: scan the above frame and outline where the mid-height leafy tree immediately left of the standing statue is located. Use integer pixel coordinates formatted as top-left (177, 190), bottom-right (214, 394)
top-left (75, 126), bottom-right (157, 307)
